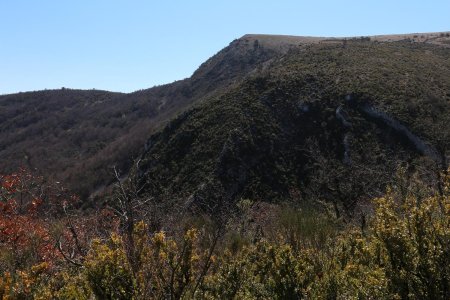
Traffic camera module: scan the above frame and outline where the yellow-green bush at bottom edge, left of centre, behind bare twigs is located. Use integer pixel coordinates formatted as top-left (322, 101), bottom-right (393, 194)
top-left (84, 222), bottom-right (213, 299)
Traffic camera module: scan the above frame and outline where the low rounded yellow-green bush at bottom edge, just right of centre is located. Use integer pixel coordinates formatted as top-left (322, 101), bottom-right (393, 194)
top-left (204, 241), bottom-right (315, 299)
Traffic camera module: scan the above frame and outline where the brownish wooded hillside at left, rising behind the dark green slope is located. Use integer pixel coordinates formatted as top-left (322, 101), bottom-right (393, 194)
top-left (0, 35), bottom-right (287, 199)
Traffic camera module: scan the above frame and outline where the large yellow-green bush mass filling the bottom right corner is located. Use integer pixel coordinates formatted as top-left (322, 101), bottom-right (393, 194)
top-left (310, 182), bottom-right (450, 299)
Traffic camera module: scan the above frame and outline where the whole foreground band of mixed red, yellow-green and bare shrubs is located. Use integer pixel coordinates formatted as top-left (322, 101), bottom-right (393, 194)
top-left (0, 166), bottom-right (450, 299)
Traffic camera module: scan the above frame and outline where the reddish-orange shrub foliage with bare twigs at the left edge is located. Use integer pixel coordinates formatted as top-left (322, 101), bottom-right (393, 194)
top-left (0, 169), bottom-right (116, 266)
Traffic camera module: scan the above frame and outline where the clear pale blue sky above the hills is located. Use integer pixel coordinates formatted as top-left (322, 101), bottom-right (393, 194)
top-left (0, 0), bottom-right (450, 94)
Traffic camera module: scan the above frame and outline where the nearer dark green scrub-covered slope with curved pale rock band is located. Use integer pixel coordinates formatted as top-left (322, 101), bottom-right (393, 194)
top-left (140, 39), bottom-right (450, 216)
